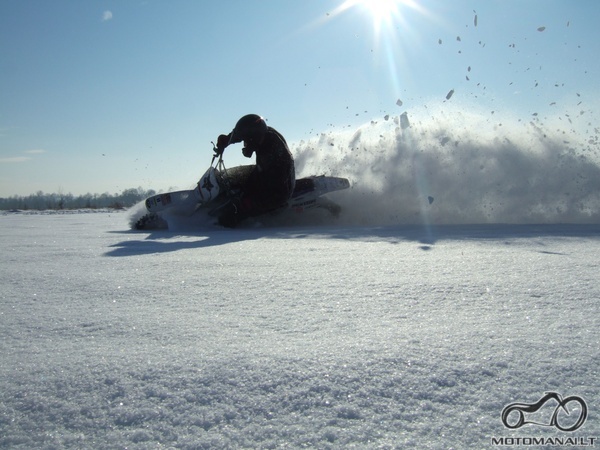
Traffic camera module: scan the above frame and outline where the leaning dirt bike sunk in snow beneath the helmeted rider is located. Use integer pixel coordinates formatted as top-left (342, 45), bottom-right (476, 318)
top-left (133, 143), bottom-right (350, 230)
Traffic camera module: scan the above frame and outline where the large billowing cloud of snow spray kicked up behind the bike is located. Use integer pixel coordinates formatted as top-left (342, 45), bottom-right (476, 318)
top-left (293, 105), bottom-right (600, 225)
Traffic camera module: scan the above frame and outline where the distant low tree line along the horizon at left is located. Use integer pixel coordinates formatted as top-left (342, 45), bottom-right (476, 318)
top-left (0, 187), bottom-right (156, 210)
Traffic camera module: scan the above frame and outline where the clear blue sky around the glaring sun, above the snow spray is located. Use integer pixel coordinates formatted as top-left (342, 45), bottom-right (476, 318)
top-left (0, 0), bottom-right (600, 196)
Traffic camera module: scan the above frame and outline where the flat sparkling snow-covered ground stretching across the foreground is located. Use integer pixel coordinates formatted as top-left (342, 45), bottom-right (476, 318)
top-left (0, 212), bottom-right (600, 449)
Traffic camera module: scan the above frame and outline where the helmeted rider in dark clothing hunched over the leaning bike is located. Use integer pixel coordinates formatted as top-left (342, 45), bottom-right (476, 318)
top-left (215, 114), bottom-right (296, 227)
